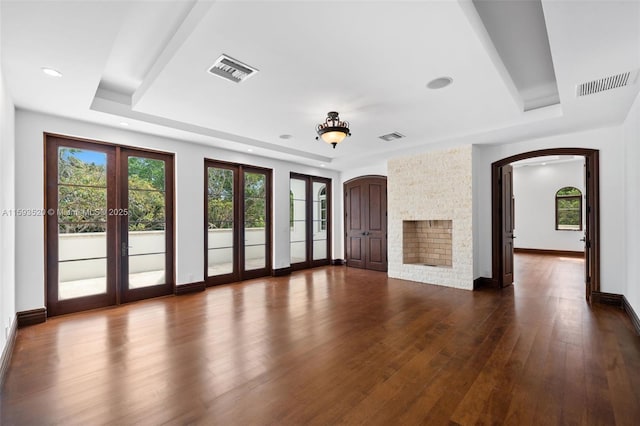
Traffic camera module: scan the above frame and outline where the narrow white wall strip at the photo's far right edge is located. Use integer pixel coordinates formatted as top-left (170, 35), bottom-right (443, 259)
top-left (623, 91), bottom-right (640, 315)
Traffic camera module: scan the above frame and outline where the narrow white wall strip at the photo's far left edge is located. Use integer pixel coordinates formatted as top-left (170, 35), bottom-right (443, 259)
top-left (0, 50), bottom-right (16, 353)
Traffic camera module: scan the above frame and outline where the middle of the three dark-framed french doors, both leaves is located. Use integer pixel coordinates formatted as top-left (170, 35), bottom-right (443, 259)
top-left (204, 160), bottom-right (271, 286)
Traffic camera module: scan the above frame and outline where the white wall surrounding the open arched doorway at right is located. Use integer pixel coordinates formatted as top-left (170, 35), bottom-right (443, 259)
top-left (473, 126), bottom-right (637, 294)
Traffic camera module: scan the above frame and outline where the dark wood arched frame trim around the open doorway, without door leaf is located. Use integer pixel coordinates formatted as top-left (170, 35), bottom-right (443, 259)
top-left (491, 148), bottom-right (600, 301)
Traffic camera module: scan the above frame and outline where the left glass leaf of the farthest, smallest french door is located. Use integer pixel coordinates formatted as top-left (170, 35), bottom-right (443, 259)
top-left (289, 178), bottom-right (307, 264)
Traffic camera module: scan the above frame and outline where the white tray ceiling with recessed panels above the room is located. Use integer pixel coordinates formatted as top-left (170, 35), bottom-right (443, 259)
top-left (0, 0), bottom-right (640, 170)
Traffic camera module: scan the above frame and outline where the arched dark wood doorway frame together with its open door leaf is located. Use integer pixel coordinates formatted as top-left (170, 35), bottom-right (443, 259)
top-left (491, 148), bottom-right (600, 301)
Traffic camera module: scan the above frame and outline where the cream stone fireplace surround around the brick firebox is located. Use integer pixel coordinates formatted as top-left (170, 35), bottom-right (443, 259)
top-left (387, 145), bottom-right (473, 290)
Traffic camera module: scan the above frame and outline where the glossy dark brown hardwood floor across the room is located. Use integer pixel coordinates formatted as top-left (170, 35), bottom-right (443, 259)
top-left (0, 254), bottom-right (640, 425)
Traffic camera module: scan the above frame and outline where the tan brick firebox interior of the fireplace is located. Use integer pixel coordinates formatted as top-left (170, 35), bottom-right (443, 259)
top-left (402, 220), bottom-right (452, 267)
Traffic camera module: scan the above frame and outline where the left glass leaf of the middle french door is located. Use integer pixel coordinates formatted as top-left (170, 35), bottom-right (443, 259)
top-left (206, 167), bottom-right (237, 277)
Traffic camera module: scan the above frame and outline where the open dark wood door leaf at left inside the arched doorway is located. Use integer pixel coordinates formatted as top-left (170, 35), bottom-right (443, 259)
top-left (500, 165), bottom-right (515, 287)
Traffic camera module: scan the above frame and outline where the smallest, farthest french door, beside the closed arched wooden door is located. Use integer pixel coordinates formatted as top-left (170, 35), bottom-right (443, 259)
top-left (289, 173), bottom-right (331, 270)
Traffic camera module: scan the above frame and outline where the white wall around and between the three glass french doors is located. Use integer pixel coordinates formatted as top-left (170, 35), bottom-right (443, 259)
top-left (15, 110), bottom-right (342, 311)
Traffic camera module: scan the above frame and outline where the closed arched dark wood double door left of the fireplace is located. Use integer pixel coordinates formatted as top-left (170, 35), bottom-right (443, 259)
top-left (344, 176), bottom-right (387, 271)
